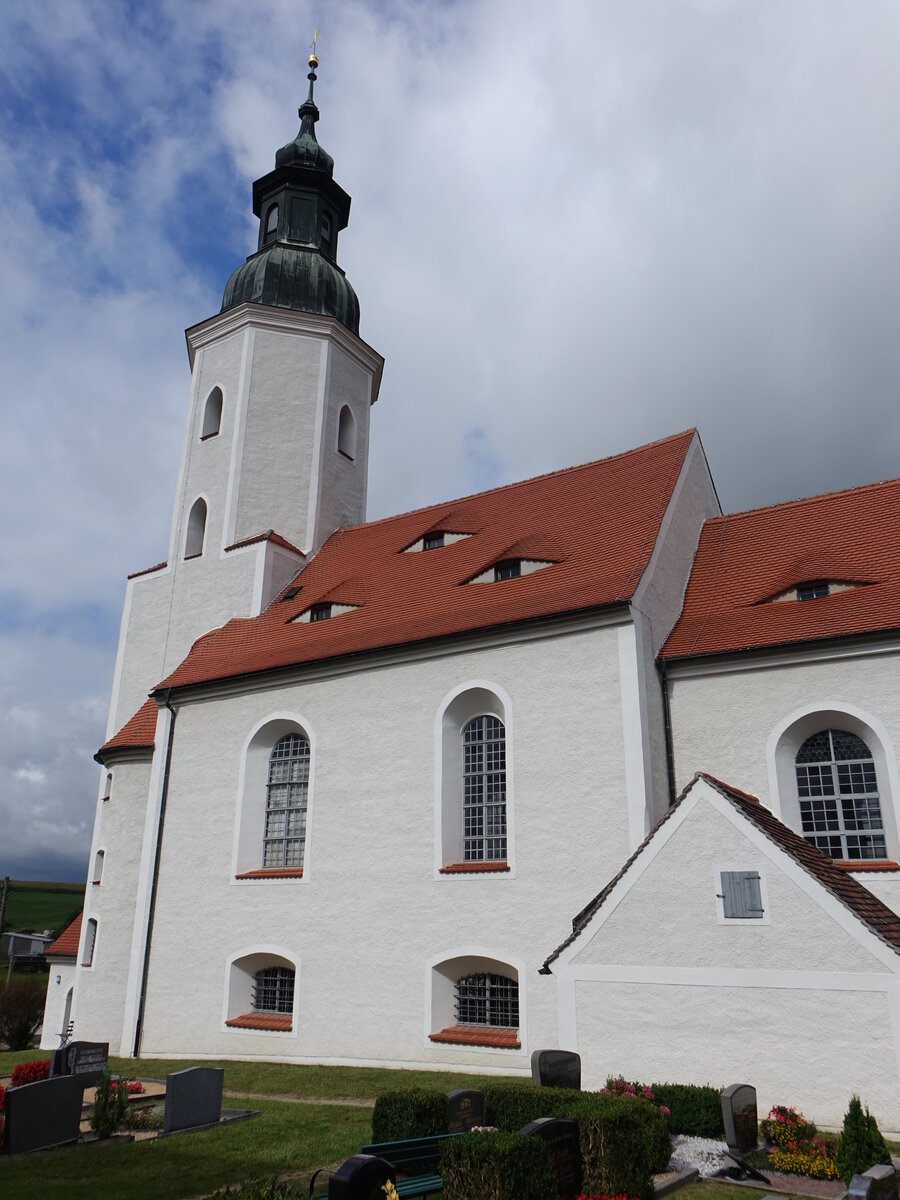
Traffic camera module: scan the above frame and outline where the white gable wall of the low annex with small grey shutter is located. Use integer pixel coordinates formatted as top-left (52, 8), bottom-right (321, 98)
top-left (553, 781), bottom-right (900, 1128)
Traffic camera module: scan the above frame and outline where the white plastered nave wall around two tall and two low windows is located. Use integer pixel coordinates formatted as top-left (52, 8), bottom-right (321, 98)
top-left (120, 618), bottom-right (629, 1073)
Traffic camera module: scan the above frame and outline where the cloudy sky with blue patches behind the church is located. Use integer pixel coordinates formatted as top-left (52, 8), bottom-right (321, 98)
top-left (0, 0), bottom-right (900, 880)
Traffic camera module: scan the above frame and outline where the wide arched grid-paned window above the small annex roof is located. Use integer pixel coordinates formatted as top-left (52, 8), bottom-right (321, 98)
top-left (796, 730), bottom-right (888, 859)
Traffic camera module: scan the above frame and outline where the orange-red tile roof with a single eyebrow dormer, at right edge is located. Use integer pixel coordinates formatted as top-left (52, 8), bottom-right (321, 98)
top-left (661, 479), bottom-right (900, 659)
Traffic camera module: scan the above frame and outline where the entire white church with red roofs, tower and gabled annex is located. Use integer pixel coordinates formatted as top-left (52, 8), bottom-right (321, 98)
top-left (44, 54), bottom-right (900, 1128)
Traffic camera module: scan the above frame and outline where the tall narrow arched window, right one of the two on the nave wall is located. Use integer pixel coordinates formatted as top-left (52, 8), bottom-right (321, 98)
top-left (462, 716), bottom-right (506, 863)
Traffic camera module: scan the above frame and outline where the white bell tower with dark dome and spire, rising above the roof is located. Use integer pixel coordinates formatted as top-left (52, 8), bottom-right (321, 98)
top-left (109, 54), bottom-right (384, 733)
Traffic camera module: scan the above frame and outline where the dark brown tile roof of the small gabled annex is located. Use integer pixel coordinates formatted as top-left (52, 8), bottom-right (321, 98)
top-left (541, 770), bottom-right (900, 974)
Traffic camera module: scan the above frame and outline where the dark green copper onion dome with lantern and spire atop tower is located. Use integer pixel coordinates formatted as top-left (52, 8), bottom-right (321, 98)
top-left (222, 54), bottom-right (359, 334)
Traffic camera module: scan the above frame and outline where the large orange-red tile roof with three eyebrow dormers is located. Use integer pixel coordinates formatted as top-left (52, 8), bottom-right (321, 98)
top-left (157, 431), bottom-right (694, 688)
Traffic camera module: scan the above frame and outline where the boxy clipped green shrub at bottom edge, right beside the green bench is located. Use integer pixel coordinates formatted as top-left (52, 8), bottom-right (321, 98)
top-left (439, 1128), bottom-right (557, 1200)
